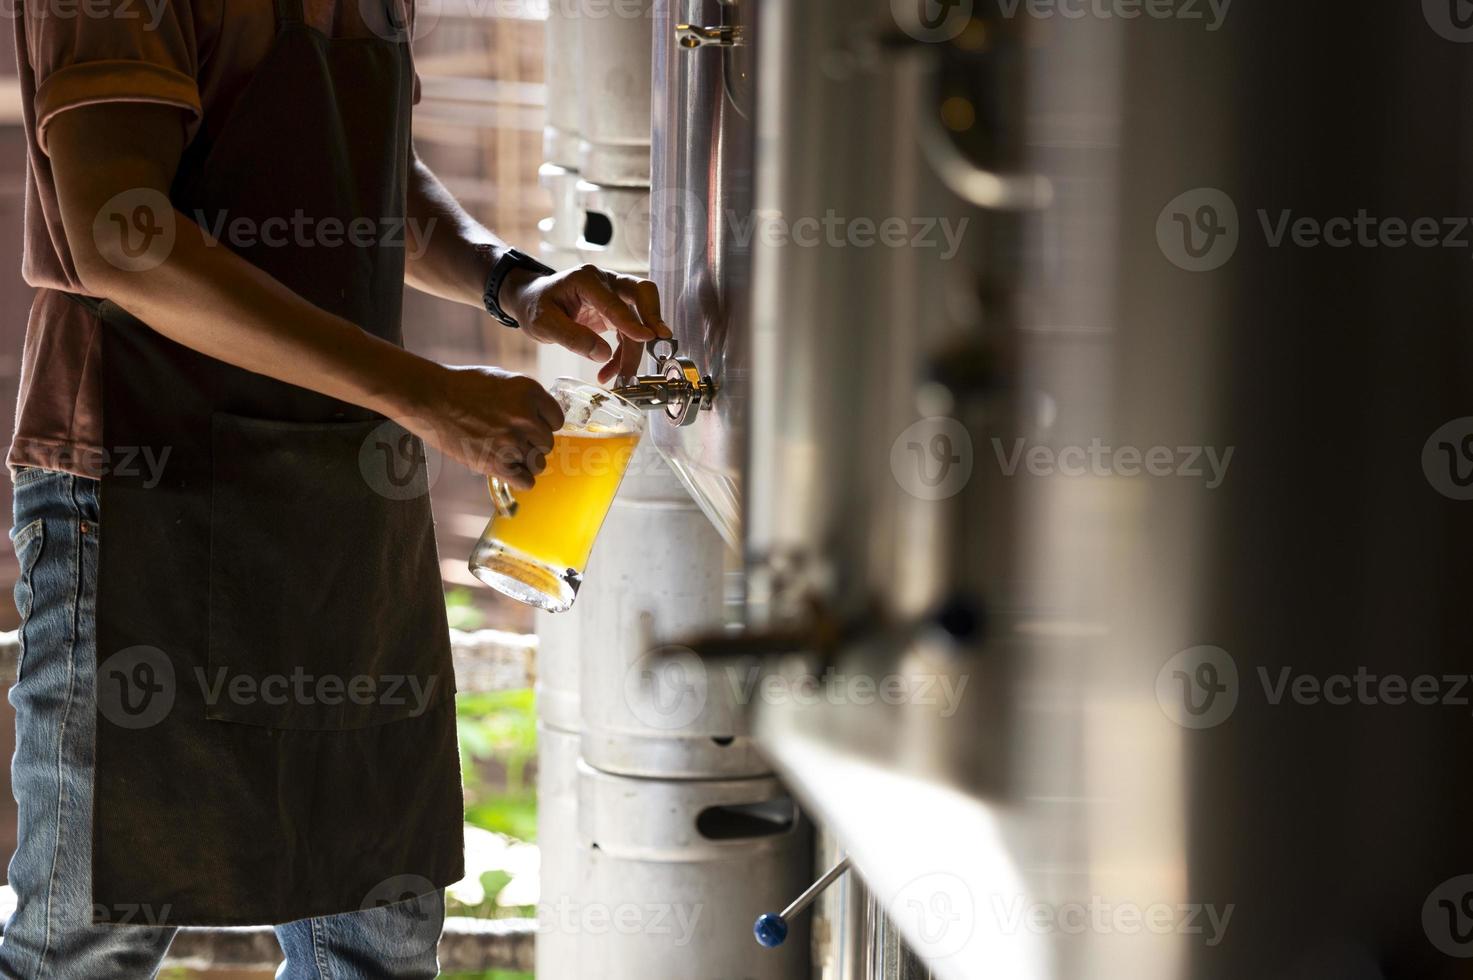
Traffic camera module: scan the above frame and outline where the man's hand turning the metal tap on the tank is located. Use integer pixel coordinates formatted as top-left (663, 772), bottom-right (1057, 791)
top-left (501, 265), bottom-right (670, 385)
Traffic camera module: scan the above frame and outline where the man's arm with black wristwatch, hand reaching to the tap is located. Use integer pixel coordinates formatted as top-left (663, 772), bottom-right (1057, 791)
top-left (405, 150), bottom-right (670, 383)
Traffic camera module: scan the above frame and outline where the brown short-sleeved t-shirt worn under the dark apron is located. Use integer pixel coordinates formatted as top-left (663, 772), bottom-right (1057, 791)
top-left (9, 0), bottom-right (418, 476)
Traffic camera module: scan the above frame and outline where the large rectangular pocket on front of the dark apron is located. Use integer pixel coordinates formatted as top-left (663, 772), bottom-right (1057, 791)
top-left (197, 413), bottom-right (455, 729)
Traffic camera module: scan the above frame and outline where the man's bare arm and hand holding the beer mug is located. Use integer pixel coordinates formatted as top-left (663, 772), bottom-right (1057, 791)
top-left (49, 103), bottom-right (563, 489)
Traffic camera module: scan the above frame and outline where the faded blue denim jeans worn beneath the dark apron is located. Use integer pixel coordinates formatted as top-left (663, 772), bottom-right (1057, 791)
top-left (0, 469), bottom-right (445, 980)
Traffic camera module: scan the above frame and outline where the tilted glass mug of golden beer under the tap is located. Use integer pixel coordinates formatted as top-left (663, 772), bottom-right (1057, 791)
top-left (470, 377), bottom-right (645, 613)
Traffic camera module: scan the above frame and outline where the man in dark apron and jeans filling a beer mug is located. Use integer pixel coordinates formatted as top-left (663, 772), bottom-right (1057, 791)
top-left (0, 0), bottom-right (669, 980)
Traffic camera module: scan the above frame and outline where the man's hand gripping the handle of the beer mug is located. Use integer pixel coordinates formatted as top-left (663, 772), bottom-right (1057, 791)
top-left (402, 364), bottom-right (563, 489)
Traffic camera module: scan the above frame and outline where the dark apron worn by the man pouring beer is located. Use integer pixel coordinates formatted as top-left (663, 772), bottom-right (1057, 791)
top-left (73, 0), bottom-right (463, 925)
